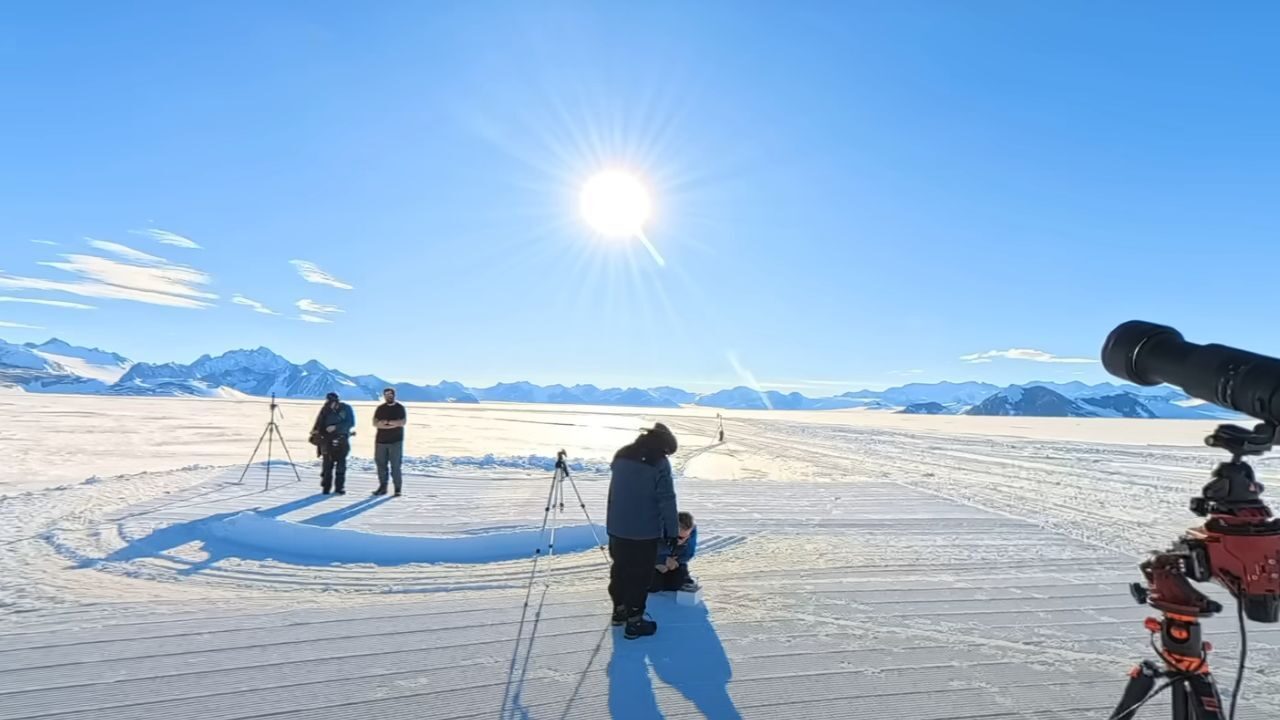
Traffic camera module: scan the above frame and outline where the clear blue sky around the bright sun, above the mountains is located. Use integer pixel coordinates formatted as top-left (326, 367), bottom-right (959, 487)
top-left (0, 1), bottom-right (1280, 395)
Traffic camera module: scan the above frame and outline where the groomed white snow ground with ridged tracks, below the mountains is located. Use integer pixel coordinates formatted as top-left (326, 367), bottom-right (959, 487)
top-left (0, 393), bottom-right (1280, 720)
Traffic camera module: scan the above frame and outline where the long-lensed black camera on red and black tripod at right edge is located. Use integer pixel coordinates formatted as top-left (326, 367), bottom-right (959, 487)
top-left (1102, 320), bottom-right (1280, 720)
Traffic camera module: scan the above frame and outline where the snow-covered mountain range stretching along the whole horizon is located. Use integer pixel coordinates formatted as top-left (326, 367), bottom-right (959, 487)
top-left (0, 338), bottom-right (1238, 419)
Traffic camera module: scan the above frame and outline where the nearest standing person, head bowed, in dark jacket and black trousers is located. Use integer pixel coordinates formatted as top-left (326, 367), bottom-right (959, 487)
top-left (607, 423), bottom-right (680, 641)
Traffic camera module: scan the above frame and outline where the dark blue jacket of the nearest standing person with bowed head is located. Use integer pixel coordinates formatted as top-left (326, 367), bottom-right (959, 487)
top-left (605, 454), bottom-right (680, 539)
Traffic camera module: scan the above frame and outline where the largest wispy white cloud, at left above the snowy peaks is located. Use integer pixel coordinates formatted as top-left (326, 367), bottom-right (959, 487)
top-left (0, 243), bottom-right (218, 309)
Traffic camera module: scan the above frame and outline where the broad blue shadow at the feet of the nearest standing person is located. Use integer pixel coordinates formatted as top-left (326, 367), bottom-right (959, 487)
top-left (608, 596), bottom-right (741, 720)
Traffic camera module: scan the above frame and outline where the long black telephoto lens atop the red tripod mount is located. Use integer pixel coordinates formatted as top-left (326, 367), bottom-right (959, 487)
top-left (1102, 320), bottom-right (1280, 424)
